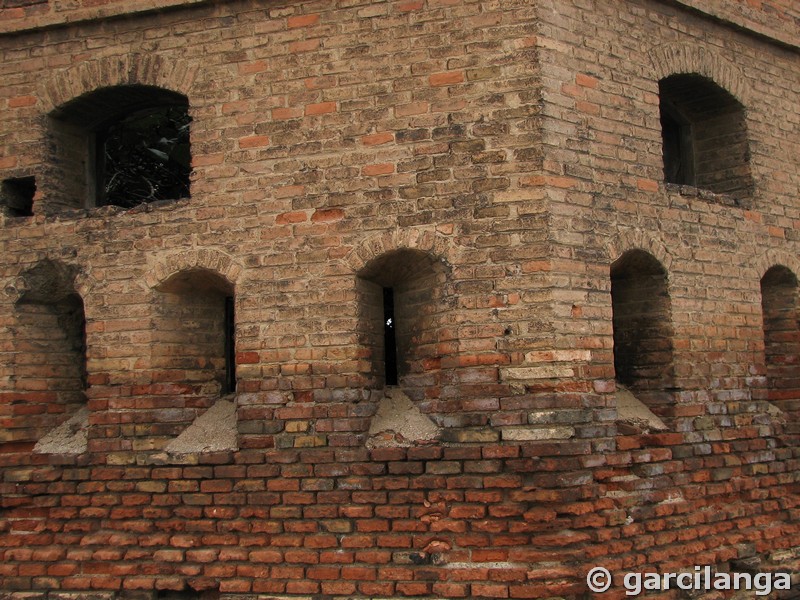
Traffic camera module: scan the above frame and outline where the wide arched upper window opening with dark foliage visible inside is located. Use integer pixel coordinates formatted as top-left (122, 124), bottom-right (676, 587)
top-left (48, 85), bottom-right (191, 212)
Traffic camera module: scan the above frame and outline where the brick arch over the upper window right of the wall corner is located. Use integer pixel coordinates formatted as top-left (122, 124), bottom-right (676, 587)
top-left (650, 43), bottom-right (749, 105)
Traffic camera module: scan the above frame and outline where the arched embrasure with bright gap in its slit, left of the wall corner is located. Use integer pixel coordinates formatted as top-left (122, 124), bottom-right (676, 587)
top-left (357, 249), bottom-right (444, 387)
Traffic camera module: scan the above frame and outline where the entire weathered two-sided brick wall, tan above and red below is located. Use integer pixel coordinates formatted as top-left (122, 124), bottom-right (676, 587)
top-left (0, 0), bottom-right (800, 598)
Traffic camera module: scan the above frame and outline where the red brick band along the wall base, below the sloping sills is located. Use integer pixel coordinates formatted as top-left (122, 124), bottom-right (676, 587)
top-left (0, 420), bottom-right (800, 598)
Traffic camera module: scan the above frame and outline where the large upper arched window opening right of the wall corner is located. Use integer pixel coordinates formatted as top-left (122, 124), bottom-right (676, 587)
top-left (658, 74), bottom-right (753, 199)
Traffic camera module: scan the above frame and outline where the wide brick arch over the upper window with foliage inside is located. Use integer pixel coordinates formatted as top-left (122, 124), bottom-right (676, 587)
top-left (39, 54), bottom-right (198, 113)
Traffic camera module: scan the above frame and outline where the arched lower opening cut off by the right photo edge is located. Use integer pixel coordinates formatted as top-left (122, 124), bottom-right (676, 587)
top-left (761, 266), bottom-right (800, 422)
